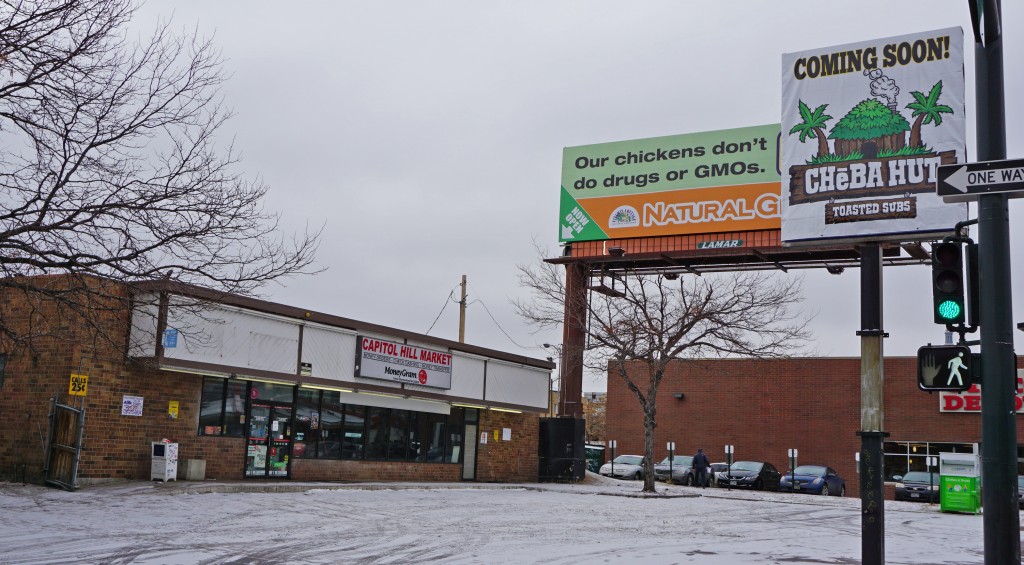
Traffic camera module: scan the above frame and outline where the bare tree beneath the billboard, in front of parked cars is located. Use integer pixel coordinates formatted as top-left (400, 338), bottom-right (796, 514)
top-left (513, 250), bottom-right (808, 492)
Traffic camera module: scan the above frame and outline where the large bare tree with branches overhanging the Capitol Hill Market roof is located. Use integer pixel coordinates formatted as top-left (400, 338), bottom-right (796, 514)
top-left (0, 0), bottom-right (319, 350)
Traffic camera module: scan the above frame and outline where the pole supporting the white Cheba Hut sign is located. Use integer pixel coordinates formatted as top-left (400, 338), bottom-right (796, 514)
top-left (857, 244), bottom-right (889, 565)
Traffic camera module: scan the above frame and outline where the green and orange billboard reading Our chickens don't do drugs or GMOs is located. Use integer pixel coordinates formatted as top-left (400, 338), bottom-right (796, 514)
top-left (558, 124), bottom-right (780, 243)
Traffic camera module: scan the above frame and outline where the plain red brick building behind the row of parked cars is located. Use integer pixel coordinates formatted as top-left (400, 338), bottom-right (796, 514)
top-left (605, 357), bottom-right (1024, 495)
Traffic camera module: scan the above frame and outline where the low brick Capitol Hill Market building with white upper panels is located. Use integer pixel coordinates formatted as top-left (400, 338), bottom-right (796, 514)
top-left (0, 276), bottom-right (554, 488)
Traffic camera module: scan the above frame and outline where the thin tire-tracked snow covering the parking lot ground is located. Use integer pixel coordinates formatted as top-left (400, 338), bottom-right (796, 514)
top-left (0, 474), bottom-right (999, 565)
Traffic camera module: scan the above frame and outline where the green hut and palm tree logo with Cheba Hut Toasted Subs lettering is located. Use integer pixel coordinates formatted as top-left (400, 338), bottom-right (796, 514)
top-left (788, 73), bottom-right (956, 224)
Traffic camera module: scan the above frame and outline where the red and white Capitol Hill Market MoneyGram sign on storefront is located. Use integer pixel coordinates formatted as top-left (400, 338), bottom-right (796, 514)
top-left (355, 336), bottom-right (452, 389)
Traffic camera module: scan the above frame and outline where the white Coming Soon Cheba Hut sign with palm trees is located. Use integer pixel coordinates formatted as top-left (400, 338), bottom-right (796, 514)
top-left (781, 28), bottom-right (967, 243)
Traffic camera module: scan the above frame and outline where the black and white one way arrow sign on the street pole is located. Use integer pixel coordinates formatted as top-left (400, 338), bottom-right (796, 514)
top-left (936, 159), bottom-right (1024, 202)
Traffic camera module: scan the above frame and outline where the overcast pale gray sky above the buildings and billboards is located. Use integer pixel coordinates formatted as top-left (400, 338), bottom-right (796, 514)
top-left (136, 0), bottom-right (1024, 391)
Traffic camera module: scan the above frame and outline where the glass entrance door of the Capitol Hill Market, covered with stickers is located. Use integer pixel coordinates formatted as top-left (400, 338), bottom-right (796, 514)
top-left (246, 402), bottom-right (292, 477)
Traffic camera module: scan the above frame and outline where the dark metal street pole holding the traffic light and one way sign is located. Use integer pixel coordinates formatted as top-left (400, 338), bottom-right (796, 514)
top-left (971, 0), bottom-right (1021, 565)
